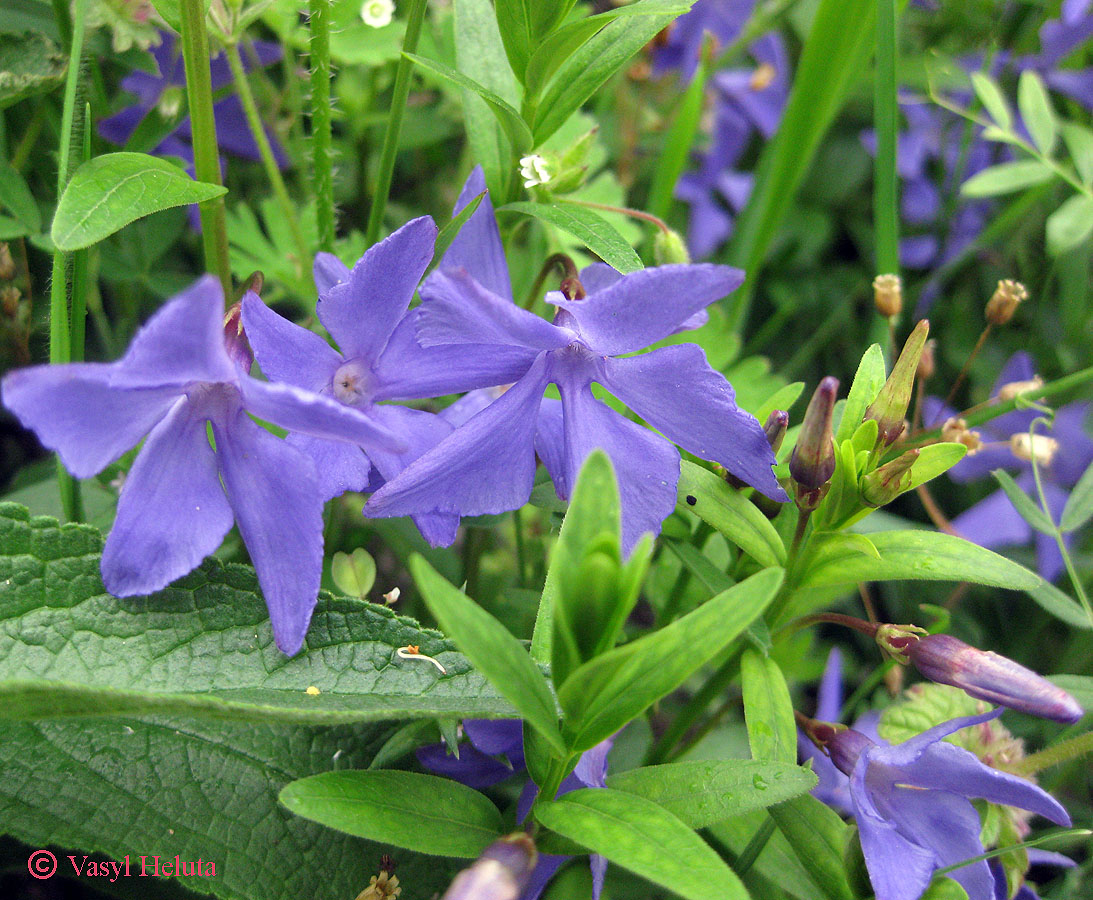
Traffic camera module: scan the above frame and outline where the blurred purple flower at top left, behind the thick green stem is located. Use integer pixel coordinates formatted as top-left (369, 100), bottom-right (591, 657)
top-left (98, 32), bottom-right (289, 175)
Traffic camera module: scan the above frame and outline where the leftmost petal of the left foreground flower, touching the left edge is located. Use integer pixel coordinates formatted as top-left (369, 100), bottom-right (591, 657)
top-left (0, 363), bottom-right (179, 478)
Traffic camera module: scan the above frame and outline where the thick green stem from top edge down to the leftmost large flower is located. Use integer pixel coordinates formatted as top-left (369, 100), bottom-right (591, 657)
top-left (179, 0), bottom-right (232, 303)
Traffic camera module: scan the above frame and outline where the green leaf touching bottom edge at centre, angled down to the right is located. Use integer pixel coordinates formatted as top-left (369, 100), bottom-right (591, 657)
top-left (536, 787), bottom-right (749, 900)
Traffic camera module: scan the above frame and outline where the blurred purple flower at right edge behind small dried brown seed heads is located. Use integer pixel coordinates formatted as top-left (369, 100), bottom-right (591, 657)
top-left (922, 351), bottom-right (1093, 581)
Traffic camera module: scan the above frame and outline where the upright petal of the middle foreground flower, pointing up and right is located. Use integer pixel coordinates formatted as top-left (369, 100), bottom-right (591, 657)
top-left (316, 215), bottom-right (436, 363)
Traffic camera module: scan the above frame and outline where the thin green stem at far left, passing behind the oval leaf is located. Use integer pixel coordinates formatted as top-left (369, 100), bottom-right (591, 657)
top-left (49, 0), bottom-right (87, 522)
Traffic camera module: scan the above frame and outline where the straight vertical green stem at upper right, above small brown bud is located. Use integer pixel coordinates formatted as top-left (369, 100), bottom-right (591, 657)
top-left (873, 0), bottom-right (900, 274)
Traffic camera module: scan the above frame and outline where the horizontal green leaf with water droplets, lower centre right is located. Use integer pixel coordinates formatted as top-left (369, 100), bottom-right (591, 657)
top-left (607, 759), bottom-right (819, 828)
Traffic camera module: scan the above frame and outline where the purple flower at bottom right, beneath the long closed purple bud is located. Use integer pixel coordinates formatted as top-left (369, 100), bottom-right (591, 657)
top-left (828, 710), bottom-right (1070, 900)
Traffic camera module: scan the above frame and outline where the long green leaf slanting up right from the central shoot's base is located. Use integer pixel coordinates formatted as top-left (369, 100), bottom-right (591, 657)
top-left (559, 568), bottom-right (783, 752)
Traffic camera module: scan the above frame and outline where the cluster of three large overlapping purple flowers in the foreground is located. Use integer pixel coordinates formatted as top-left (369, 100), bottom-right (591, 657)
top-left (2, 170), bottom-right (786, 654)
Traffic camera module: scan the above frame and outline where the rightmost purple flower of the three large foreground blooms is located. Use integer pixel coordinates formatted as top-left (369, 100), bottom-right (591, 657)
top-left (365, 176), bottom-right (786, 551)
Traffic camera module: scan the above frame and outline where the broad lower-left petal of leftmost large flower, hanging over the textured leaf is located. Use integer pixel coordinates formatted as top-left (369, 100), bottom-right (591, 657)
top-left (102, 399), bottom-right (232, 597)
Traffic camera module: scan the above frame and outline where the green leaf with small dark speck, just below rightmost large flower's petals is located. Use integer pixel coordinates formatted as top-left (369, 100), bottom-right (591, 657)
top-left (678, 459), bottom-right (786, 565)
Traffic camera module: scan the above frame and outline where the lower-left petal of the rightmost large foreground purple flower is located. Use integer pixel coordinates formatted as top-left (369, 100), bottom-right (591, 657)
top-left (364, 354), bottom-right (549, 516)
